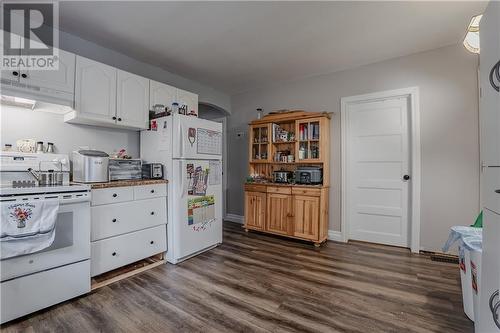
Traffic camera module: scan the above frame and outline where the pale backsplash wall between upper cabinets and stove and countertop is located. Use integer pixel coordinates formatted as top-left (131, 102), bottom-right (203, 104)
top-left (0, 105), bottom-right (140, 157)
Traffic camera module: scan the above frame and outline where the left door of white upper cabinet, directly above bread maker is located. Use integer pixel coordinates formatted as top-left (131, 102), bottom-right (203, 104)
top-left (75, 56), bottom-right (117, 124)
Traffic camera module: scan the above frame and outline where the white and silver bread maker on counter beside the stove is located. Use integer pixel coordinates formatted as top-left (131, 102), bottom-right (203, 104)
top-left (72, 150), bottom-right (109, 183)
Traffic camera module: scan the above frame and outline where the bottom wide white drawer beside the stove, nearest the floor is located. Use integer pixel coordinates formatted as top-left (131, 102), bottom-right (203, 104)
top-left (90, 225), bottom-right (167, 276)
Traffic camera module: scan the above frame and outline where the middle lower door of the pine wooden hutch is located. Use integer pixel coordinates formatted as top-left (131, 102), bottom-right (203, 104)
top-left (266, 193), bottom-right (292, 235)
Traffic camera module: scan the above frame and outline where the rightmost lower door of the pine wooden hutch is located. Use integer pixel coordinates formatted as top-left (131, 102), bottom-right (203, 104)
top-left (293, 195), bottom-right (320, 240)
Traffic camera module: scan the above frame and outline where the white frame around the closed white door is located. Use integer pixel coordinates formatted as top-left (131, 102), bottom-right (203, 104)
top-left (340, 87), bottom-right (421, 253)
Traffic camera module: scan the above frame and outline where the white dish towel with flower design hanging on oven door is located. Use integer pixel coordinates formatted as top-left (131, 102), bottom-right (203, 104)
top-left (0, 200), bottom-right (59, 259)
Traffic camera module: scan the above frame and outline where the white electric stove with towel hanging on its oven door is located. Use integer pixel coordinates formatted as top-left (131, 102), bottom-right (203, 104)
top-left (0, 152), bottom-right (90, 323)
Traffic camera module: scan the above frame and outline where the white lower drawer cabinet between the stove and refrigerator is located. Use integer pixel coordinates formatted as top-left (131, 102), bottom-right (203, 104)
top-left (90, 183), bottom-right (167, 276)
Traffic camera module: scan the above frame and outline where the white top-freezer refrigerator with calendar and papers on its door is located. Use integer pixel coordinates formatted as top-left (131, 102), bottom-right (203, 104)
top-left (141, 114), bottom-right (223, 264)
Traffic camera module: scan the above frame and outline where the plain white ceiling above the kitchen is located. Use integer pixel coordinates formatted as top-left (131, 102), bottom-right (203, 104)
top-left (60, 1), bottom-right (485, 93)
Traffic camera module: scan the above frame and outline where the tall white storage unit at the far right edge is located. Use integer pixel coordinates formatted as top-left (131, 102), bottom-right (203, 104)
top-left (475, 1), bottom-right (500, 333)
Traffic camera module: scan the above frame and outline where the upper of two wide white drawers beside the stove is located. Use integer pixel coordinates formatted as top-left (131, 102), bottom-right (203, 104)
top-left (91, 197), bottom-right (167, 241)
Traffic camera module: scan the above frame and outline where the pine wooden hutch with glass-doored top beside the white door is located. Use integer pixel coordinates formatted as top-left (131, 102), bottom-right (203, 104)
top-left (245, 111), bottom-right (330, 246)
